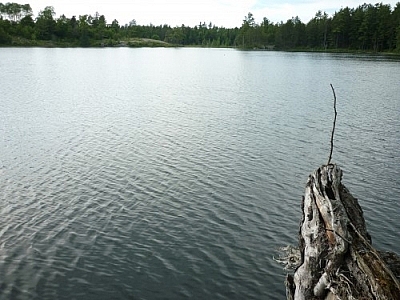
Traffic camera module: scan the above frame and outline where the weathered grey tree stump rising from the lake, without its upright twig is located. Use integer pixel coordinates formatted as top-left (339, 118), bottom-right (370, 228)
top-left (285, 164), bottom-right (400, 300)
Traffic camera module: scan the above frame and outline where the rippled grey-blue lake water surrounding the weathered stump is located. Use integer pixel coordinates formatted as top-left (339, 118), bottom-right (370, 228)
top-left (0, 48), bottom-right (400, 299)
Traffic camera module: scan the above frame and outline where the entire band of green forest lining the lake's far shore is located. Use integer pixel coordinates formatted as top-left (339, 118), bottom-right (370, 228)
top-left (0, 2), bottom-right (400, 53)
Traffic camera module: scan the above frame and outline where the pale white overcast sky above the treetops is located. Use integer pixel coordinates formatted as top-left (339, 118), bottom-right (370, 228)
top-left (26, 0), bottom-right (399, 28)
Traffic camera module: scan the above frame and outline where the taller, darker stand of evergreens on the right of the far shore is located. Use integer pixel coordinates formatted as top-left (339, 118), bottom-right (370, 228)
top-left (239, 2), bottom-right (400, 52)
